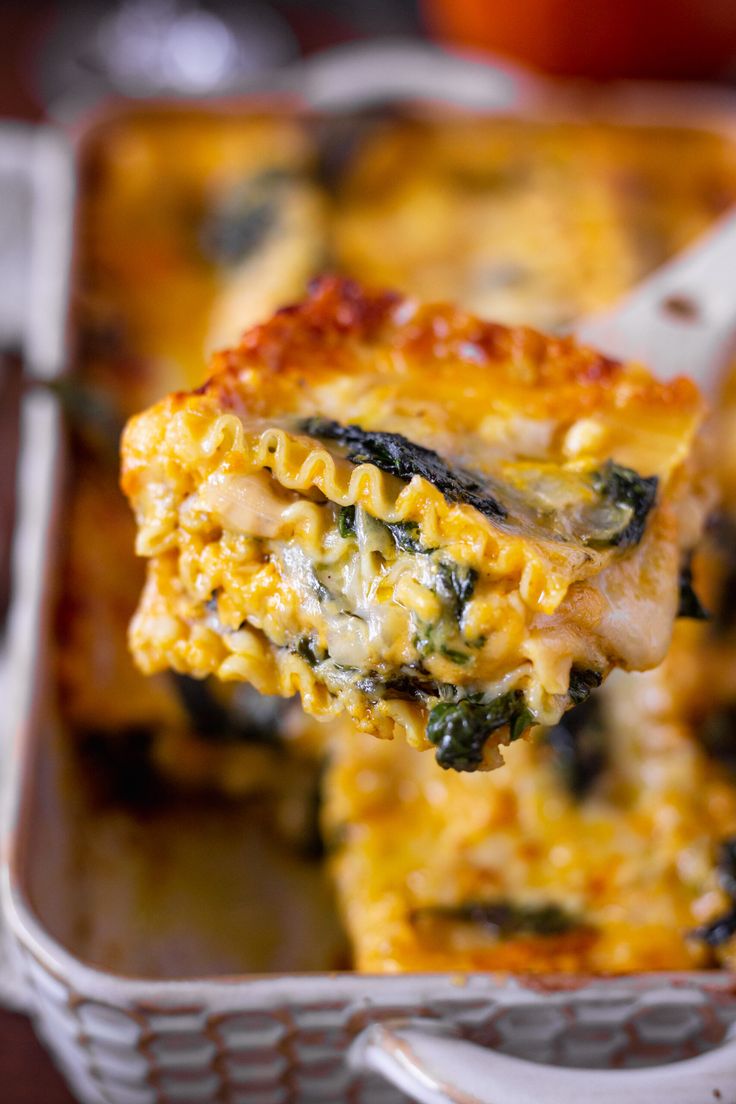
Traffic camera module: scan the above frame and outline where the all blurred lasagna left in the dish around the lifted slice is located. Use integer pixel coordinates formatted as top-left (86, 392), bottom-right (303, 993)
top-left (56, 105), bottom-right (736, 973)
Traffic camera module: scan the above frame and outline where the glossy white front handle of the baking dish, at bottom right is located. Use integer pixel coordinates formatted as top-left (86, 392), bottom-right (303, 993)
top-left (348, 1020), bottom-right (736, 1104)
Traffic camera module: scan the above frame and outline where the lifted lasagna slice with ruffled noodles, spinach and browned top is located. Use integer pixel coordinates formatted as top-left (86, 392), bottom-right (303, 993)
top-left (122, 277), bottom-right (707, 771)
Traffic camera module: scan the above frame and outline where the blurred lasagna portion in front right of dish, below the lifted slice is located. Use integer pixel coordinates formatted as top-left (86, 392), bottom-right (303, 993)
top-left (323, 662), bottom-right (736, 975)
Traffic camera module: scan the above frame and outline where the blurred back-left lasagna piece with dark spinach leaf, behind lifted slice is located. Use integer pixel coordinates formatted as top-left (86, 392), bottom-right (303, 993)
top-left (76, 107), bottom-right (327, 412)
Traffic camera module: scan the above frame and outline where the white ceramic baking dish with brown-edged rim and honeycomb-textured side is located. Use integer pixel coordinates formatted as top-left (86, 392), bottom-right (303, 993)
top-left (2, 46), bottom-right (736, 1104)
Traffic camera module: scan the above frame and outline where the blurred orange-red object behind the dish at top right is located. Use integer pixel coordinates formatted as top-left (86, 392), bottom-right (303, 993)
top-left (424, 0), bottom-right (736, 78)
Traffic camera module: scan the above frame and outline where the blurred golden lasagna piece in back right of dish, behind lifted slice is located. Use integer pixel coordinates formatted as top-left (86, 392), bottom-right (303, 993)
top-left (331, 115), bottom-right (736, 329)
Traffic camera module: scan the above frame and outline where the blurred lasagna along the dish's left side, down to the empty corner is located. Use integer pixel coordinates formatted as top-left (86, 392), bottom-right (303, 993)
top-left (56, 106), bottom-right (337, 834)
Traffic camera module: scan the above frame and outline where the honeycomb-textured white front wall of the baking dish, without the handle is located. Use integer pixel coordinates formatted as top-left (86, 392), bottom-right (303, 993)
top-left (17, 927), bottom-right (736, 1104)
